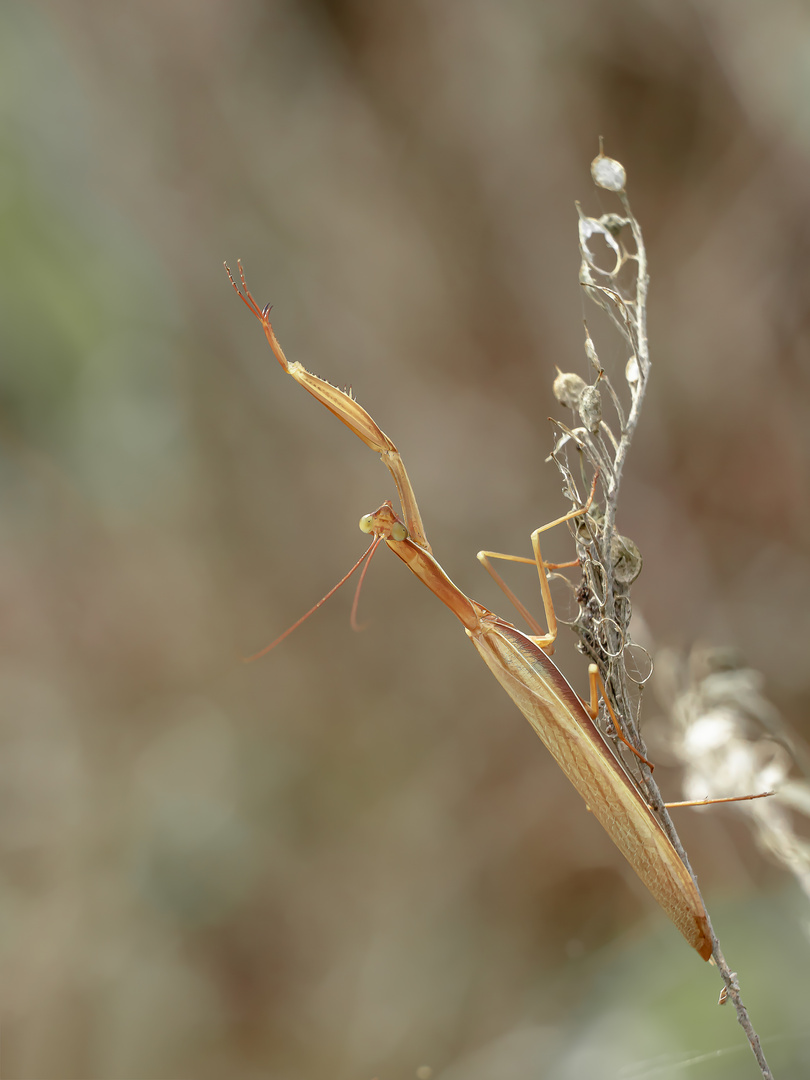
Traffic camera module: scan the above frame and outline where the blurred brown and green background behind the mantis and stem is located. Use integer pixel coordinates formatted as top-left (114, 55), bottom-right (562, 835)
top-left (0, 0), bottom-right (810, 1080)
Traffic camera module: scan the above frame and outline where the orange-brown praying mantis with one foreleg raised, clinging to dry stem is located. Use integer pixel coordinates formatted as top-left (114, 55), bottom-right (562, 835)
top-left (226, 262), bottom-right (713, 960)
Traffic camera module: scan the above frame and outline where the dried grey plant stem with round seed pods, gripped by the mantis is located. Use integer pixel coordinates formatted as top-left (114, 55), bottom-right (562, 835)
top-left (552, 151), bottom-right (771, 1080)
